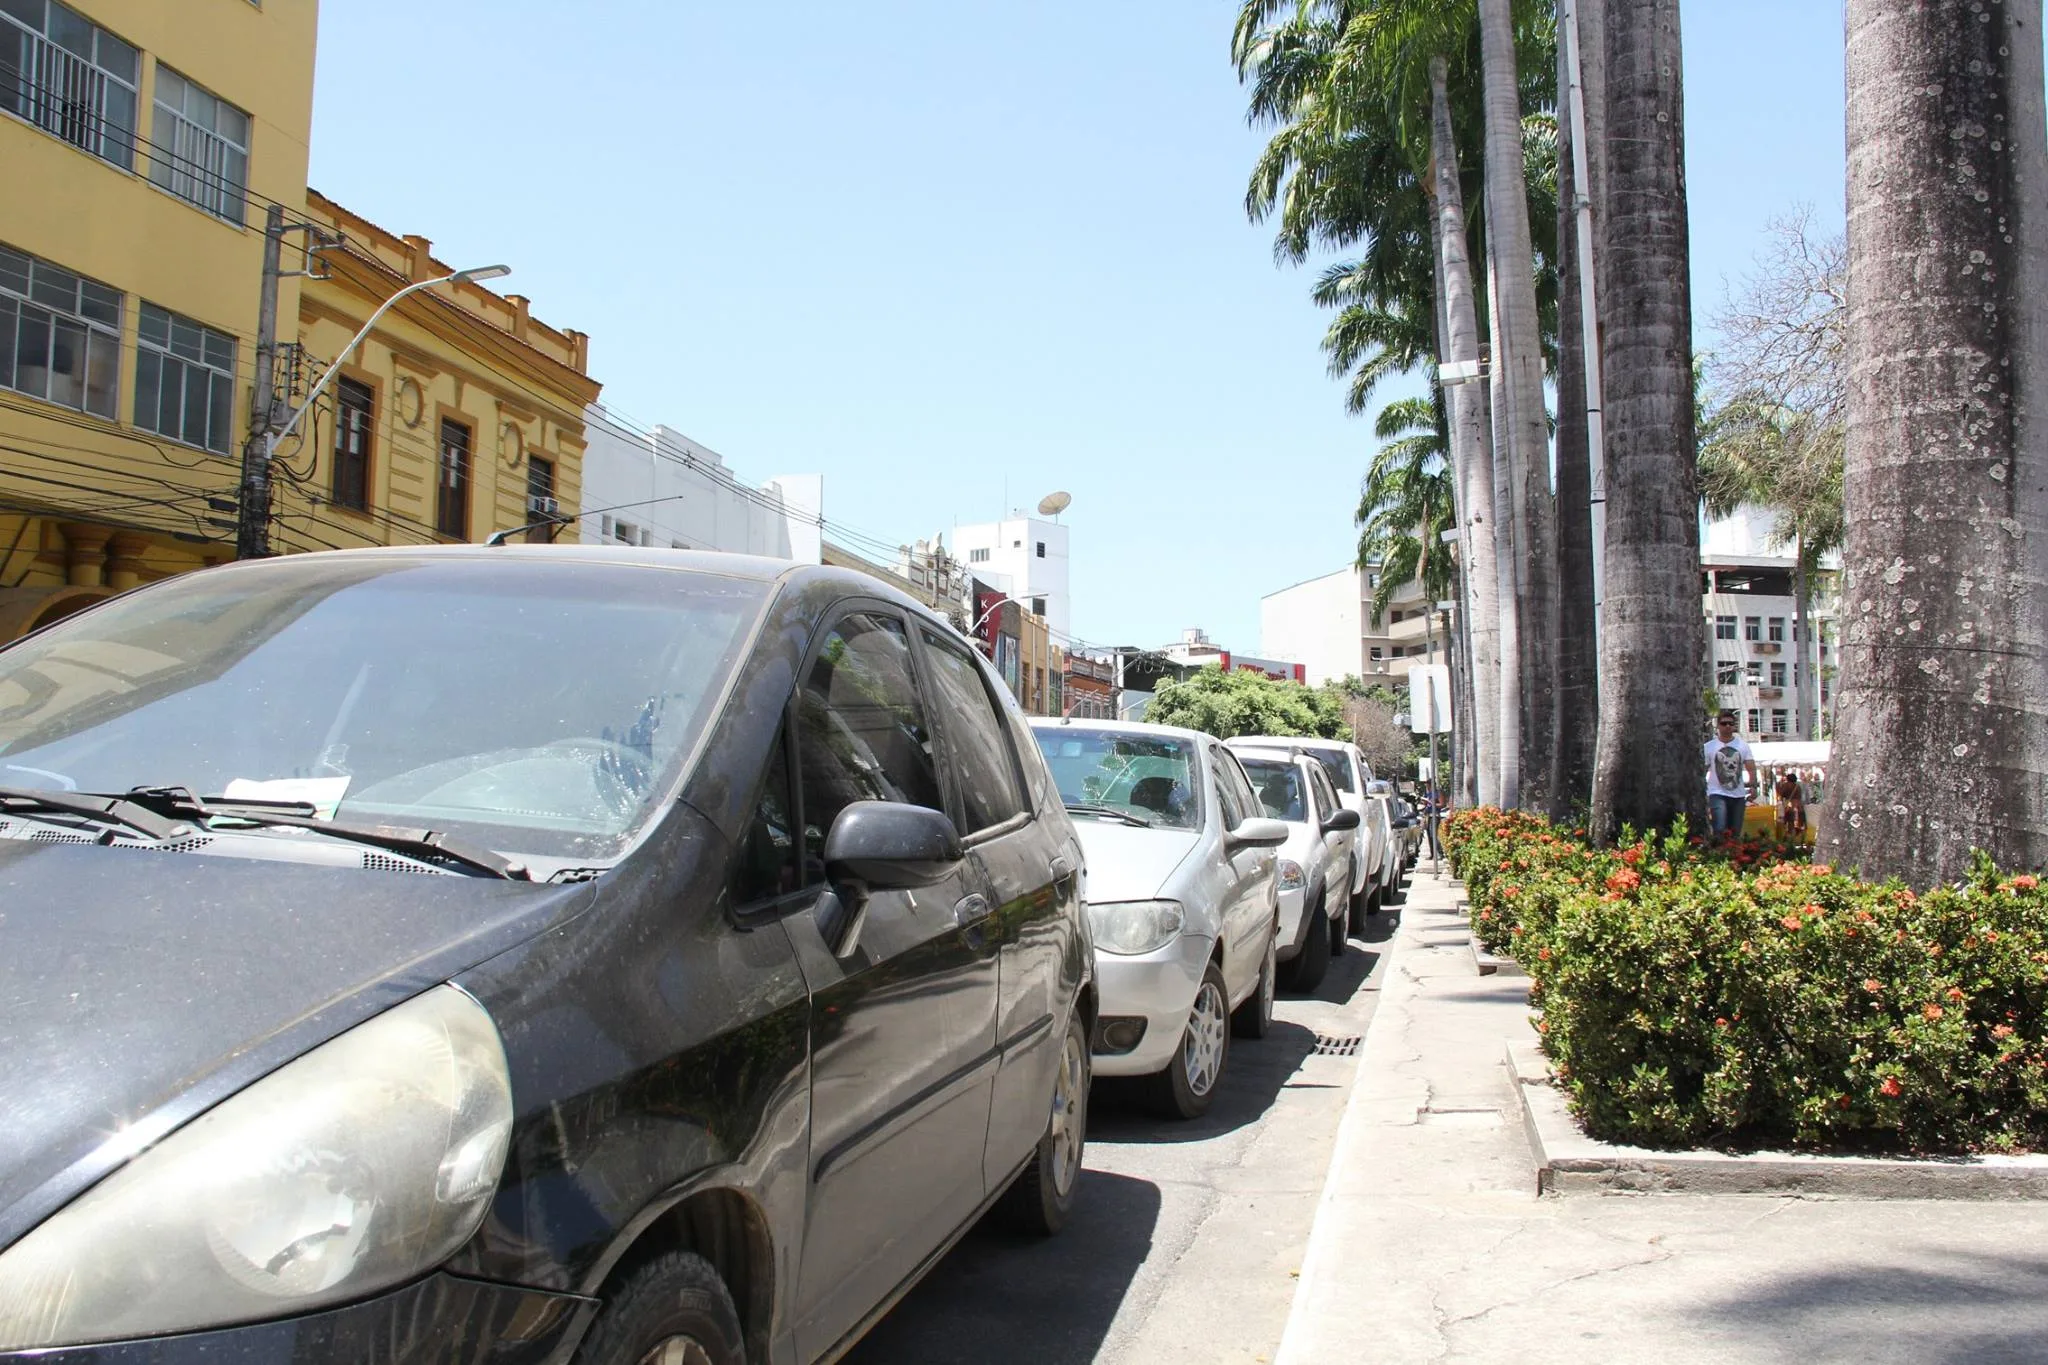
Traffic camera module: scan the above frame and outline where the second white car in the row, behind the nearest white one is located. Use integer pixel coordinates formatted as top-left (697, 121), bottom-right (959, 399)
top-left (1227, 741), bottom-right (1358, 990)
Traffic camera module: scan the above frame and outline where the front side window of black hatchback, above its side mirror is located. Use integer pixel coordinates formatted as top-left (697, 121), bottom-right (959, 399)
top-left (797, 612), bottom-right (946, 882)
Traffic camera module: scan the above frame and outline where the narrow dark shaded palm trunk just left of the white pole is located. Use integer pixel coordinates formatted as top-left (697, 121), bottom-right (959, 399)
top-left (1548, 13), bottom-right (1599, 821)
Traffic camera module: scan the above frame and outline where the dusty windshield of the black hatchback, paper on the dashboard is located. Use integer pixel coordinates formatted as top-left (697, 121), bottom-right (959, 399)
top-left (0, 555), bottom-right (770, 862)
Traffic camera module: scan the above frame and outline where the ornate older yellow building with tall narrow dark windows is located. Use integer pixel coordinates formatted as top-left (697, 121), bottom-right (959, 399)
top-left (282, 189), bottom-right (598, 551)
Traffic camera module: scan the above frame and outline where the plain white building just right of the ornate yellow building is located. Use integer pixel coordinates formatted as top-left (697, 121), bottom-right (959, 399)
top-left (577, 403), bottom-right (825, 565)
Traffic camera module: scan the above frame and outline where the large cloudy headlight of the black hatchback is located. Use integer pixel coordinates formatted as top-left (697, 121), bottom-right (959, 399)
top-left (0, 986), bottom-right (512, 1351)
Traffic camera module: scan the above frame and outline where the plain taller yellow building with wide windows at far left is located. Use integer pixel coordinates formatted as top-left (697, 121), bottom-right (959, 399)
top-left (0, 0), bottom-right (315, 641)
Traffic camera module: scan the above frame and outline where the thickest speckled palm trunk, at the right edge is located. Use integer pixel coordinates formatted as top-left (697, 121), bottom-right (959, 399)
top-left (1821, 0), bottom-right (2048, 886)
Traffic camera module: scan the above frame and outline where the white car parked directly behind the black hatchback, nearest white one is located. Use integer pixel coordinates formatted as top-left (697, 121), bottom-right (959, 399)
top-left (1030, 718), bottom-right (1288, 1117)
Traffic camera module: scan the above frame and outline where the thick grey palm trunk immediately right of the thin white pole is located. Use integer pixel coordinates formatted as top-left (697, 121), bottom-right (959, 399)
top-left (1593, 0), bottom-right (1706, 841)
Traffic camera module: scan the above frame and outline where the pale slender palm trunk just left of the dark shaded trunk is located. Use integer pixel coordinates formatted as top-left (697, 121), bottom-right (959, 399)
top-left (1479, 0), bottom-right (1561, 810)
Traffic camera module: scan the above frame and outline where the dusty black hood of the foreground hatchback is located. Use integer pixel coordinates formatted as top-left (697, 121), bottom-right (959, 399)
top-left (0, 841), bottom-right (594, 1246)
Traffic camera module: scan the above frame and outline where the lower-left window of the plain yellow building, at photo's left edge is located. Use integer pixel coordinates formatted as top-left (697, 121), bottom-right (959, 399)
top-left (0, 240), bottom-right (123, 420)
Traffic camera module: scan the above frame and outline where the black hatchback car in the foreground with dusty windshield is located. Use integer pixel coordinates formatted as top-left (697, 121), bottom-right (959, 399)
top-left (0, 546), bottom-right (1094, 1365)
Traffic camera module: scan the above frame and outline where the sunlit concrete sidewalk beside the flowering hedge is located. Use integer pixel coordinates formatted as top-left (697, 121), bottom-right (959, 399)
top-left (1278, 862), bottom-right (2048, 1365)
